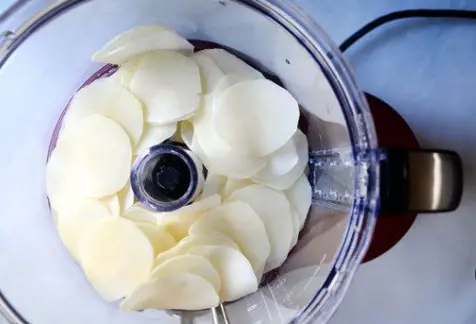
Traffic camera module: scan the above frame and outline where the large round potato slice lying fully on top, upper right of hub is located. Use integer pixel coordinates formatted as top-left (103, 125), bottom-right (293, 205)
top-left (215, 79), bottom-right (299, 156)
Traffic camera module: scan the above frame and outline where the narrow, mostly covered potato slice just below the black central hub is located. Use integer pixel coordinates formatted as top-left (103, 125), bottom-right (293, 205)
top-left (156, 194), bottom-right (221, 240)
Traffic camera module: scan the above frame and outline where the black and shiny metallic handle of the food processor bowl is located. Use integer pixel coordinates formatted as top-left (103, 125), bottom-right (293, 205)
top-left (380, 149), bottom-right (463, 215)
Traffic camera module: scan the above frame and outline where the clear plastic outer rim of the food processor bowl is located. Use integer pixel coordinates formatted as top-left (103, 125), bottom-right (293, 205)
top-left (0, 0), bottom-right (380, 324)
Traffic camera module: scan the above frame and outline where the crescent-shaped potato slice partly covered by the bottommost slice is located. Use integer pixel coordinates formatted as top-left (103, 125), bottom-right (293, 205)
top-left (150, 254), bottom-right (221, 292)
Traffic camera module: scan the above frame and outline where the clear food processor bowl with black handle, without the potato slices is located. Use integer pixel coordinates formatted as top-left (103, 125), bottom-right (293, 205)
top-left (0, 0), bottom-right (462, 324)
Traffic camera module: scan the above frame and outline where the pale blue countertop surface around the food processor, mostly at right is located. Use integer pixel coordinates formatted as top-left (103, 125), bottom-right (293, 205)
top-left (0, 0), bottom-right (476, 324)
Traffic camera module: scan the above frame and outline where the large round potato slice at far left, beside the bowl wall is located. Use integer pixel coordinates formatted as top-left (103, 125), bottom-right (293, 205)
top-left (51, 115), bottom-right (132, 200)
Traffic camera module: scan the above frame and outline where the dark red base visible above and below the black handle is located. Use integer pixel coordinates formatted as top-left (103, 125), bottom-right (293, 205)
top-left (364, 94), bottom-right (420, 263)
